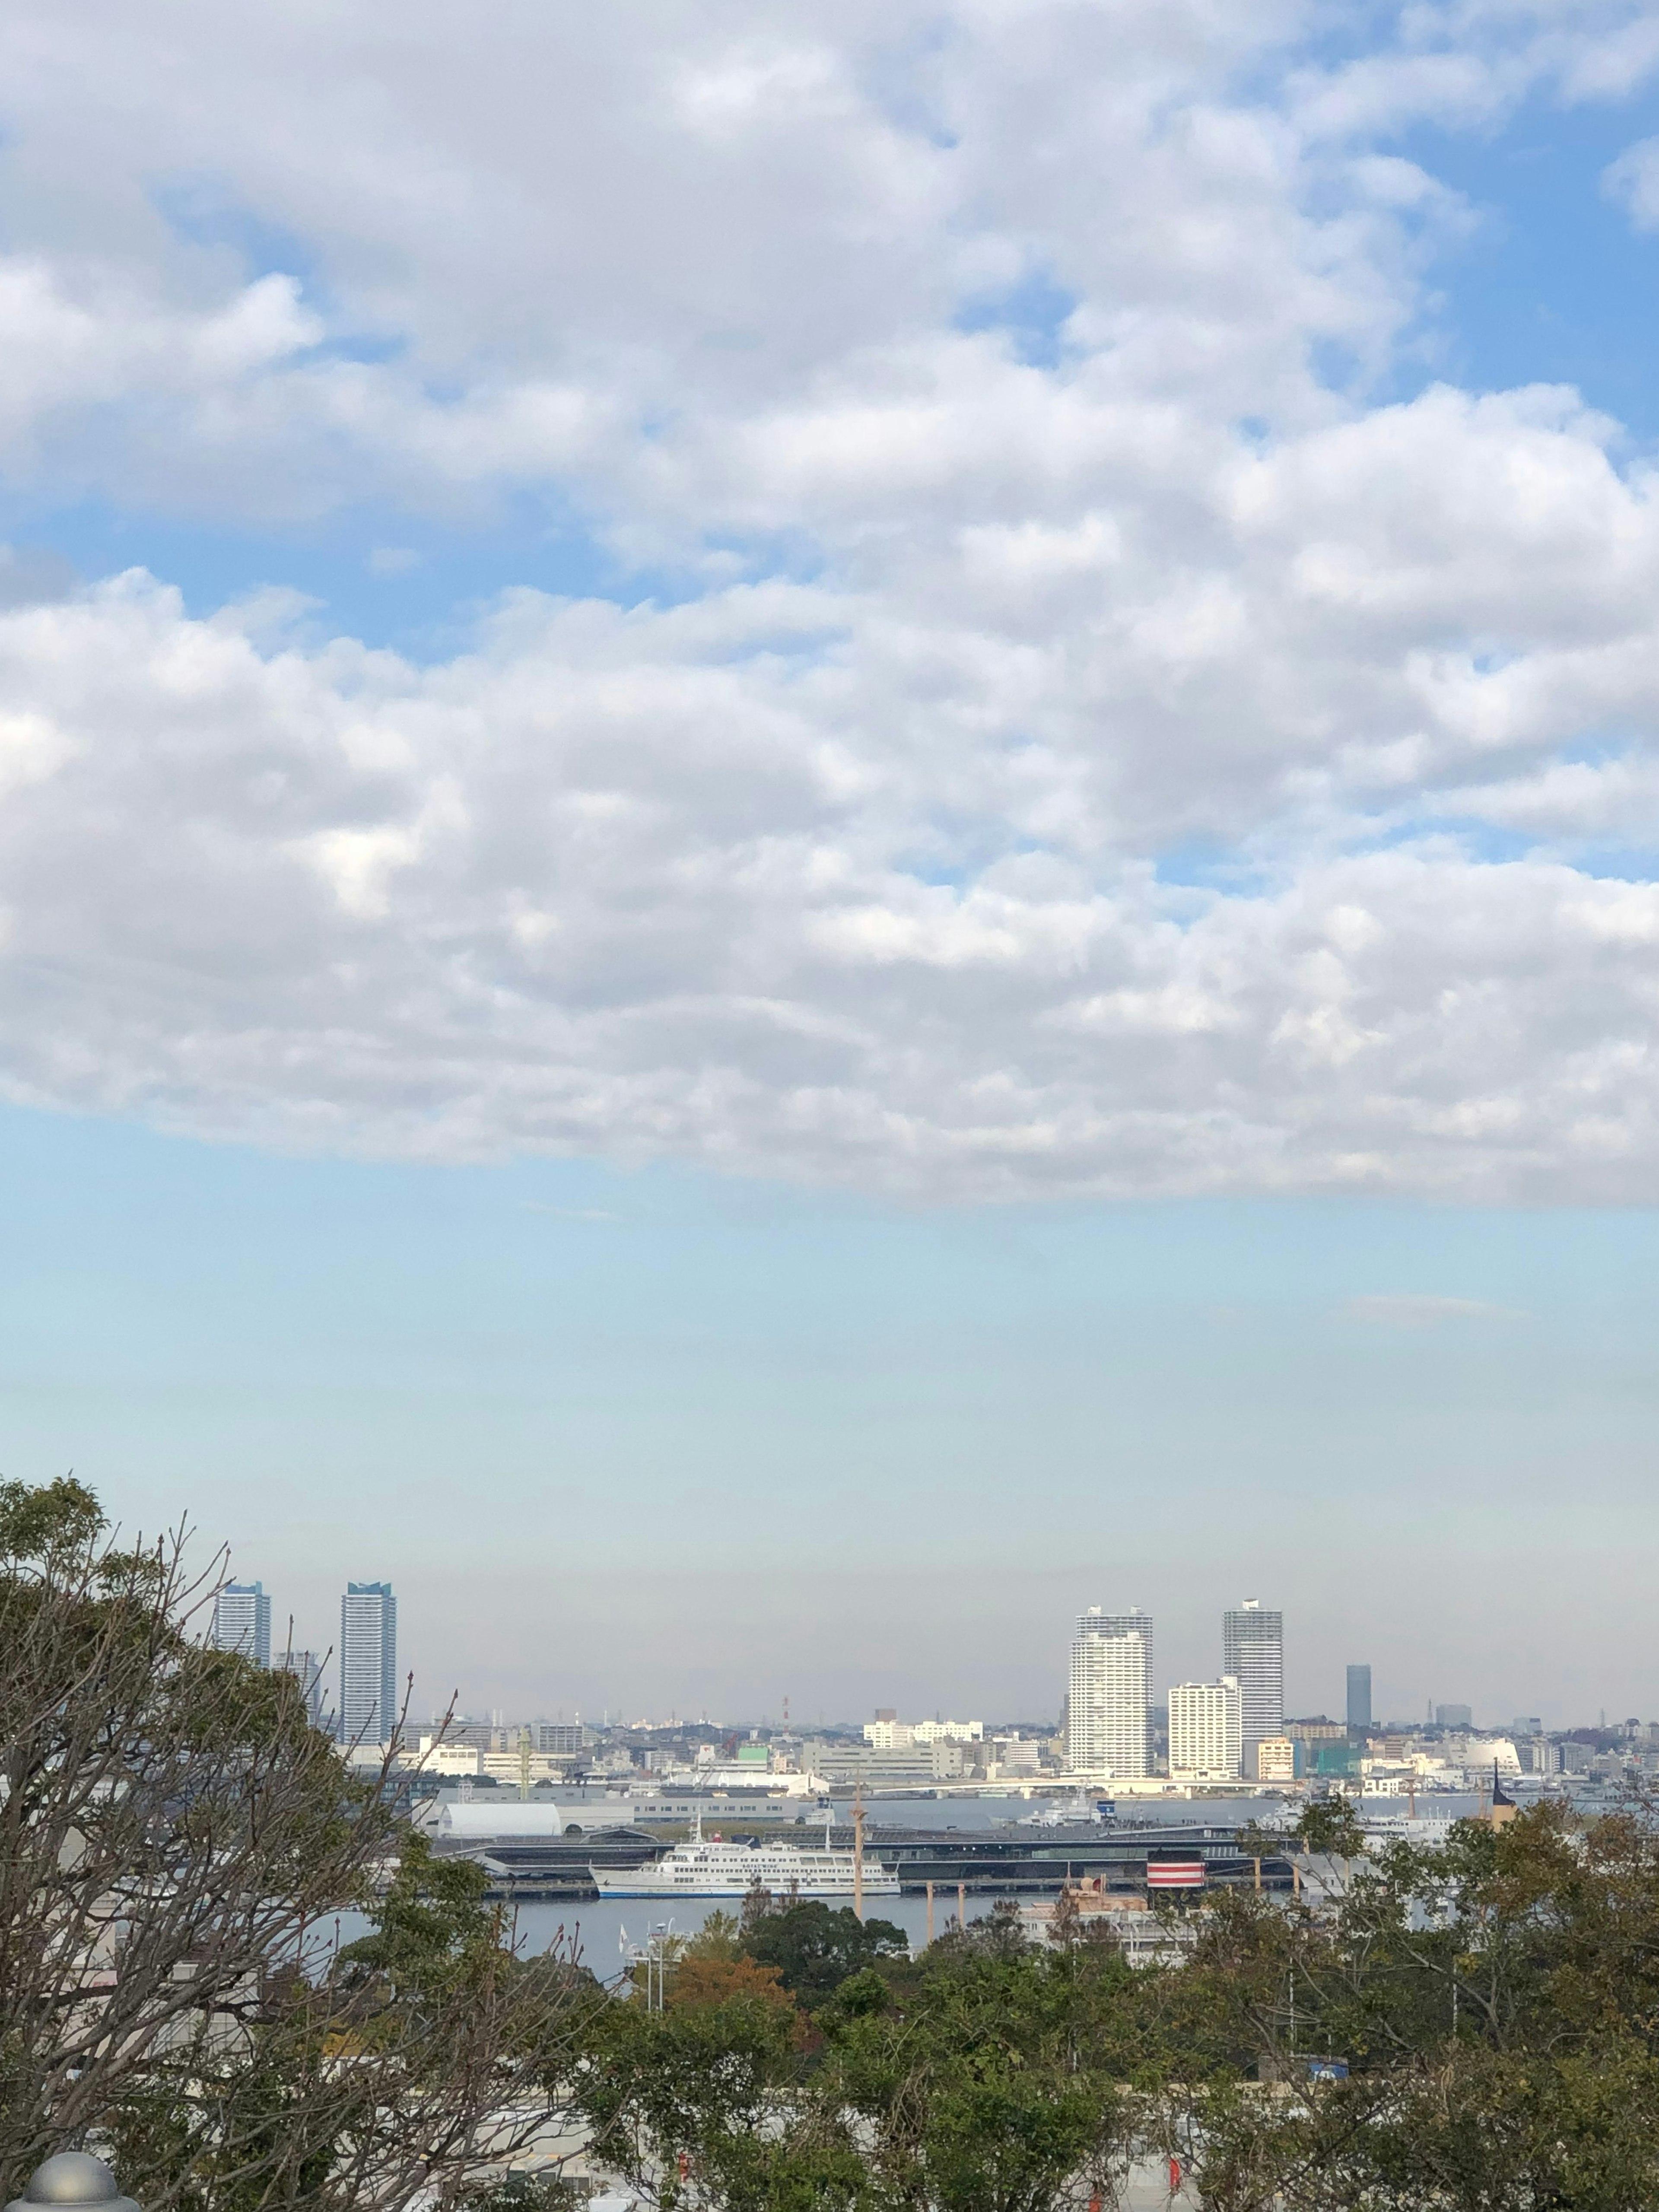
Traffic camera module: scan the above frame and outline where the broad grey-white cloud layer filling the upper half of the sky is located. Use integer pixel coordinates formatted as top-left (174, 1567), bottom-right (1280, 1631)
top-left (0, 0), bottom-right (1659, 1199)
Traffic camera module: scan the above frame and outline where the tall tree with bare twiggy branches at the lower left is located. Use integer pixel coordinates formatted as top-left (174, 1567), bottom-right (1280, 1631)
top-left (0, 1480), bottom-right (593, 2212)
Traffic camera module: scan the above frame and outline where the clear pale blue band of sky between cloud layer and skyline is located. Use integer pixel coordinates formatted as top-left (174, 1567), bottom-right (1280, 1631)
top-left (0, 1112), bottom-right (1659, 1723)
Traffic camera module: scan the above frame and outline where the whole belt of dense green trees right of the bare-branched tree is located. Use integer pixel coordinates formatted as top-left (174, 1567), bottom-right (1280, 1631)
top-left (579, 1803), bottom-right (1659, 2212)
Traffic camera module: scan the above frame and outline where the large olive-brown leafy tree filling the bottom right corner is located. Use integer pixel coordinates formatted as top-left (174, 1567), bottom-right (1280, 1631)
top-left (1163, 1805), bottom-right (1659, 2212)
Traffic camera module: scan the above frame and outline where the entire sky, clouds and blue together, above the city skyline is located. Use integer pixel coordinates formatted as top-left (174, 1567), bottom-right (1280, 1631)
top-left (0, 0), bottom-right (1659, 1721)
